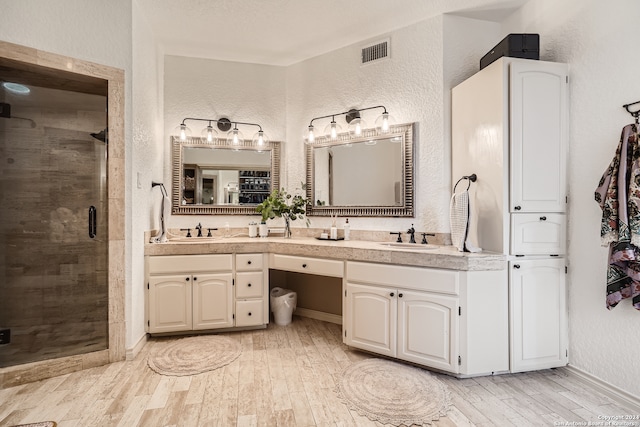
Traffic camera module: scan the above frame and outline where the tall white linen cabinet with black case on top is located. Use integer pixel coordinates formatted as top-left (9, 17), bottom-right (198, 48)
top-left (451, 57), bottom-right (569, 372)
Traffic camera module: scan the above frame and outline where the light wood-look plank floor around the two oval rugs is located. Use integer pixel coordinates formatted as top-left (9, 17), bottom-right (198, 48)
top-left (0, 316), bottom-right (640, 427)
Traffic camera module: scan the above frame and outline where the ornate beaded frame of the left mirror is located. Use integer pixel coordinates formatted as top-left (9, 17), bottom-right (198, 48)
top-left (171, 136), bottom-right (280, 215)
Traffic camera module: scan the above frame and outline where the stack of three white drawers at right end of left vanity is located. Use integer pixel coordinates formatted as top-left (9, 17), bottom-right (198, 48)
top-left (235, 253), bottom-right (269, 327)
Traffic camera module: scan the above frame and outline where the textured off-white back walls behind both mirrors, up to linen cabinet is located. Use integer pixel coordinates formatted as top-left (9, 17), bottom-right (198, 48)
top-left (164, 16), bottom-right (499, 237)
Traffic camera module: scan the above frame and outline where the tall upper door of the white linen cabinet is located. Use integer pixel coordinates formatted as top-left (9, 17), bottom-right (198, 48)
top-left (509, 61), bottom-right (569, 212)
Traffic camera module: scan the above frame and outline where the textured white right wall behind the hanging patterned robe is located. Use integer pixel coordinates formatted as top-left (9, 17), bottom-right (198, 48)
top-left (503, 0), bottom-right (640, 396)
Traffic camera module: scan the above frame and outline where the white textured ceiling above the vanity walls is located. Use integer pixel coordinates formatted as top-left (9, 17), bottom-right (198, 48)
top-left (136, 0), bottom-right (529, 66)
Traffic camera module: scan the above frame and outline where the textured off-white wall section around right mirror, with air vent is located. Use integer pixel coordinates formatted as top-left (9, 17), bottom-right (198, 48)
top-left (286, 16), bottom-right (450, 233)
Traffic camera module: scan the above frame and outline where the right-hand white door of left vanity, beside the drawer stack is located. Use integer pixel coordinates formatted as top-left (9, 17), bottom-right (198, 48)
top-left (192, 273), bottom-right (233, 330)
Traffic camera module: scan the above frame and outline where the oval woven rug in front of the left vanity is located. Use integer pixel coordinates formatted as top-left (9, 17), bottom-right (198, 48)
top-left (147, 335), bottom-right (241, 377)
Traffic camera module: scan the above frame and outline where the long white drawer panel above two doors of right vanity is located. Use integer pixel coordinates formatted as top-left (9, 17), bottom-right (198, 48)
top-left (347, 261), bottom-right (460, 295)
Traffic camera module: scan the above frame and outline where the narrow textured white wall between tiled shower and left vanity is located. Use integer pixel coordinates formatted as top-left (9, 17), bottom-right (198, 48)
top-left (131, 2), bottom-right (164, 349)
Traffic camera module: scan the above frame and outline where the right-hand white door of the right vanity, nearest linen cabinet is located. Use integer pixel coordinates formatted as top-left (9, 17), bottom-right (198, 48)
top-left (397, 289), bottom-right (458, 372)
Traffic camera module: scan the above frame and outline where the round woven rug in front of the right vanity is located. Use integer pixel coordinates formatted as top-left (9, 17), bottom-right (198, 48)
top-left (337, 359), bottom-right (451, 426)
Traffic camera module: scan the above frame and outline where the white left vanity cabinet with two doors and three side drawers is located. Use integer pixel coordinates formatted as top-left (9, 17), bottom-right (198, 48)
top-left (145, 253), bottom-right (269, 334)
